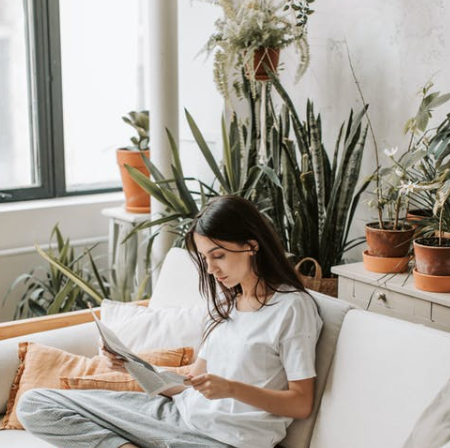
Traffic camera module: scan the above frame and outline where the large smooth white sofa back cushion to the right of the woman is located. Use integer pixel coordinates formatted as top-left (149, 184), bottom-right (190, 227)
top-left (311, 310), bottom-right (450, 448)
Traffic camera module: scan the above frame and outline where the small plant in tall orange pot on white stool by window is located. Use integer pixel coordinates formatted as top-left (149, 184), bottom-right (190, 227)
top-left (117, 110), bottom-right (150, 213)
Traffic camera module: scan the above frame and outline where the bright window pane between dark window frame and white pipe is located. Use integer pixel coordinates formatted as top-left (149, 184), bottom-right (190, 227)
top-left (60, 0), bottom-right (149, 191)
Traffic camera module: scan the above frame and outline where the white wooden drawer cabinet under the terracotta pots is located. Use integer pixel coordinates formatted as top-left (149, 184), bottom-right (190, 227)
top-left (331, 263), bottom-right (450, 331)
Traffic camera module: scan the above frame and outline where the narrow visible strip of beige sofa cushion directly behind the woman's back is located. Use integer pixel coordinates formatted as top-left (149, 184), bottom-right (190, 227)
top-left (281, 291), bottom-right (352, 448)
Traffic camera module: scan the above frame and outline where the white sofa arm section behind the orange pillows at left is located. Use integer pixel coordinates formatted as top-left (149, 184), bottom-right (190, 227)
top-left (0, 322), bottom-right (98, 414)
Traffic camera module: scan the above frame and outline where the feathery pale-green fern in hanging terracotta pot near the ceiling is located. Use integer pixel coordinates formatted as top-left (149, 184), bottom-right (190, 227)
top-left (204, 0), bottom-right (314, 99)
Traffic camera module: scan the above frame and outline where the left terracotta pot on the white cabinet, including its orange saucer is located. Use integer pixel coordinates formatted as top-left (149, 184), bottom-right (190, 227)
top-left (363, 221), bottom-right (415, 274)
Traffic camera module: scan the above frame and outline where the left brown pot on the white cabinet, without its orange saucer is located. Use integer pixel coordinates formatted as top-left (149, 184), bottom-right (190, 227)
top-left (366, 221), bottom-right (414, 258)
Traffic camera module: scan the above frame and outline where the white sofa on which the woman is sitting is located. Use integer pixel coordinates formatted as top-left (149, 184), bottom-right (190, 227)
top-left (0, 249), bottom-right (450, 448)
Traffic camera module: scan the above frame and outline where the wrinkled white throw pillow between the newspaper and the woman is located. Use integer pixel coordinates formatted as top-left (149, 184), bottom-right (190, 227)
top-left (101, 299), bottom-right (207, 356)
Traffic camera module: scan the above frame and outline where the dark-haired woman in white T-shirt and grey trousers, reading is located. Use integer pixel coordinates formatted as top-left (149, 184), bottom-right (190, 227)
top-left (18, 196), bottom-right (322, 448)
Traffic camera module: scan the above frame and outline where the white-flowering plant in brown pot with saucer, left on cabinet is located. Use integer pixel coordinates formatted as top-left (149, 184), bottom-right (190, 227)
top-left (363, 83), bottom-right (450, 273)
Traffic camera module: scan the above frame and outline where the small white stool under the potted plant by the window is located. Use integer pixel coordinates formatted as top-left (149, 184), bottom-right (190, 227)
top-left (102, 207), bottom-right (151, 294)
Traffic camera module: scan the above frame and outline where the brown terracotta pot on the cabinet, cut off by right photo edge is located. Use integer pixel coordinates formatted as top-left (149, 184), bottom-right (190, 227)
top-left (414, 237), bottom-right (450, 276)
